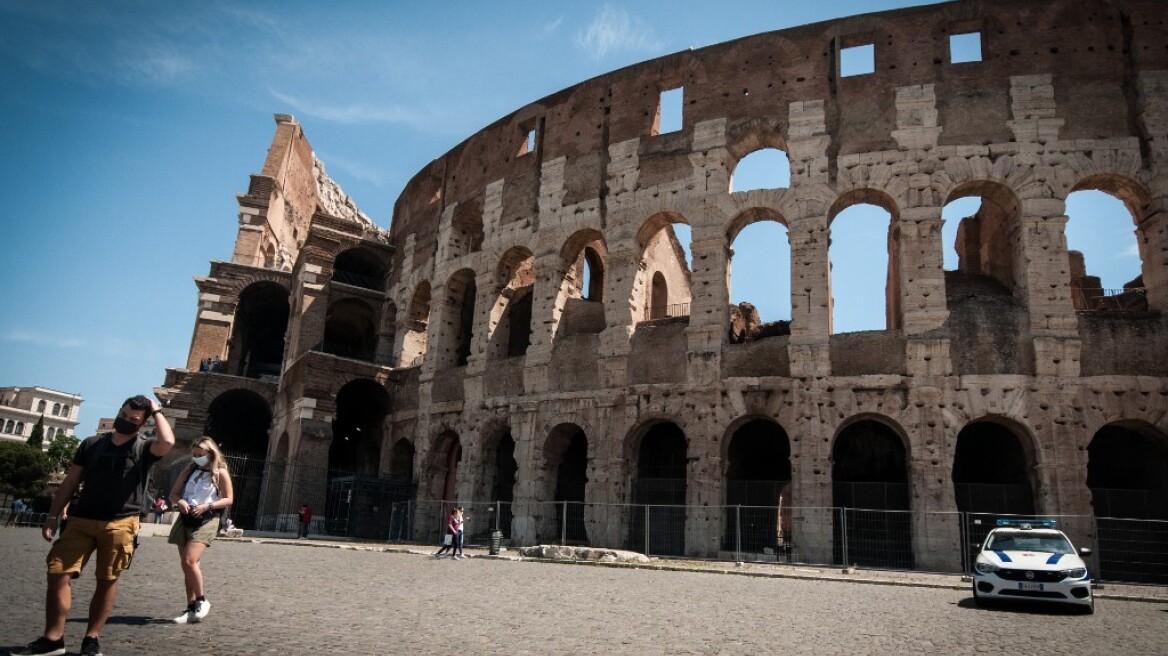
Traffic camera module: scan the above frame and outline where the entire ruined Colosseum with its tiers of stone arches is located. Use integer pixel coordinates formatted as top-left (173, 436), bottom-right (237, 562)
top-left (158, 0), bottom-right (1168, 574)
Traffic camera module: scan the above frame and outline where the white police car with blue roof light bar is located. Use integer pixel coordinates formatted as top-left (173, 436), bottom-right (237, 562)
top-left (973, 519), bottom-right (1094, 614)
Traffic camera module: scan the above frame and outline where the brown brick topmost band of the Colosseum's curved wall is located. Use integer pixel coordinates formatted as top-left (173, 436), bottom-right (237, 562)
top-left (392, 0), bottom-right (1168, 268)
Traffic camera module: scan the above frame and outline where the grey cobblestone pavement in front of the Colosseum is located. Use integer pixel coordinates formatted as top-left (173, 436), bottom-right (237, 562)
top-left (0, 529), bottom-right (1168, 655)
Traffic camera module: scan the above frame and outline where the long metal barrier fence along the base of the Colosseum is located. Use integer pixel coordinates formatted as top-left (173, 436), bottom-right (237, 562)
top-left (0, 494), bottom-right (1168, 585)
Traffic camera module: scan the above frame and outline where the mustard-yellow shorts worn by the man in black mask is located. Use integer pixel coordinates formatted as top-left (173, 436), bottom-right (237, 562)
top-left (44, 515), bottom-right (138, 581)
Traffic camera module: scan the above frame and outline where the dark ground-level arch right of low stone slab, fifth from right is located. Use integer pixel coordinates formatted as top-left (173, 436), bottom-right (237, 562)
top-left (628, 421), bottom-right (687, 556)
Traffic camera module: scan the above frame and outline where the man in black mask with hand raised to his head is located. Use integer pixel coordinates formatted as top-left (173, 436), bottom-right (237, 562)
top-left (13, 396), bottom-right (174, 656)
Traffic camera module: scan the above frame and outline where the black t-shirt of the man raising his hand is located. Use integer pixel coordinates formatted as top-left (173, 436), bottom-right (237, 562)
top-left (69, 433), bottom-right (161, 521)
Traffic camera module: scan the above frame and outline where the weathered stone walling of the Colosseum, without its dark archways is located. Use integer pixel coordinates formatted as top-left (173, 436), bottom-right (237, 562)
top-left (162, 0), bottom-right (1168, 568)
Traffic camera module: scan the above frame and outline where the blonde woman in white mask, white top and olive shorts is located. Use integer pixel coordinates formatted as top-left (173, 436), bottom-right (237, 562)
top-left (167, 437), bottom-right (232, 624)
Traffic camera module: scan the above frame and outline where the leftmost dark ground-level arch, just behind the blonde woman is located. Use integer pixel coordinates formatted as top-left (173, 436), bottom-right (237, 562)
top-left (203, 390), bottom-right (272, 529)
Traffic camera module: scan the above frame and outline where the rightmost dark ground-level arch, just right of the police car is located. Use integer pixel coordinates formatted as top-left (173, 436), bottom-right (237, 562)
top-left (1087, 424), bottom-right (1168, 585)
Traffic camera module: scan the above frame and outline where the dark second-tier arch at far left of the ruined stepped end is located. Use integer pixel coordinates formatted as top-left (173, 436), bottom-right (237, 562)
top-left (227, 282), bottom-right (291, 378)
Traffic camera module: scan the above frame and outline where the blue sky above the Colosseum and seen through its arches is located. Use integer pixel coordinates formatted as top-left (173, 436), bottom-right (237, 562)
top-left (0, 0), bottom-right (1138, 434)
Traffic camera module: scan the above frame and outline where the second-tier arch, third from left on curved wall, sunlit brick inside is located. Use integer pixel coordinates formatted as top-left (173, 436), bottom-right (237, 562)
top-left (488, 246), bottom-right (535, 360)
